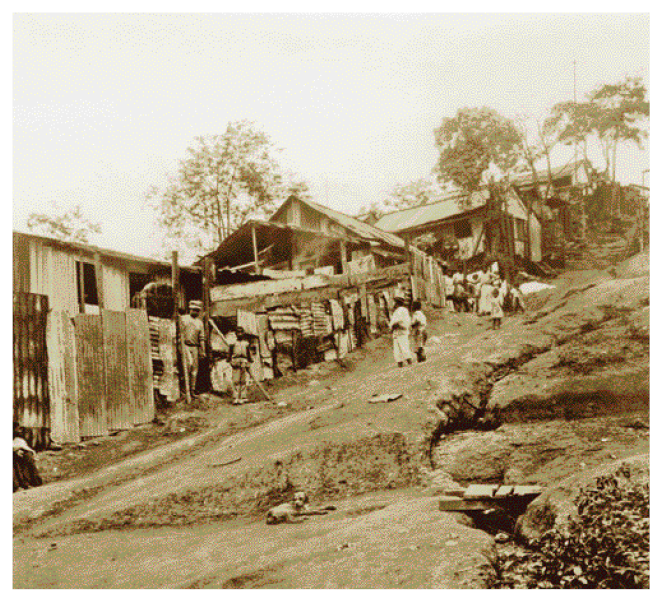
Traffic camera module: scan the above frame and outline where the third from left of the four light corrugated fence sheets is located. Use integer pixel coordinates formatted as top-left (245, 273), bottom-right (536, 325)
top-left (101, 309), bottom-right (134, 430)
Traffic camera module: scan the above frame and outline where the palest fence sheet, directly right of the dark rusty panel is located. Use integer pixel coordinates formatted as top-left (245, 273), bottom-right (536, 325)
top-left (46, 311), bottom-right (80, 443)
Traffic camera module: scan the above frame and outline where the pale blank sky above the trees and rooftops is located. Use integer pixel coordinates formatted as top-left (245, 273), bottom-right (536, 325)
top-left (13, 14), bottom-right (650, 262)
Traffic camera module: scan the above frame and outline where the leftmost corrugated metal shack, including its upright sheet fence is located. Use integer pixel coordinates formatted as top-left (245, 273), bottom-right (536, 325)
top-left (13, 232), bottom-right (202, 448)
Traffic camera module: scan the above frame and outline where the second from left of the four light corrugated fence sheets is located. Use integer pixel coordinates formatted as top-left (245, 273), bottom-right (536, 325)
top-left (74, 314), bottom-right (108, 437)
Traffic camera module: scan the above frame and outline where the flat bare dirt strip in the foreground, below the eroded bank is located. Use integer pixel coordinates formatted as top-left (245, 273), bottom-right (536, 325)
top-left (14, 490), bottom-right (490, 588)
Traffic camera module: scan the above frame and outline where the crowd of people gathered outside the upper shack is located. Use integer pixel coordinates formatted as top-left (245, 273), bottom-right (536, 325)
top-left (446, 265), bottom-right (524, 329)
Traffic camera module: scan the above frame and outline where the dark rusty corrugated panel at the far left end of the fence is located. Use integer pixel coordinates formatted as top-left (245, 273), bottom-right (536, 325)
top-left (13, 292), bottom-right (50, 448)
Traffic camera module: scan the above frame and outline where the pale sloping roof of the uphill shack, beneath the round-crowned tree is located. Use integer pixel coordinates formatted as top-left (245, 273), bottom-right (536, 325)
top-left (374, 189), bottom-right (488, 232)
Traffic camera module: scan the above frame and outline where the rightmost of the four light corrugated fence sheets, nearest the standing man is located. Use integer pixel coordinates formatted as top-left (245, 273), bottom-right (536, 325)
top-left (126, 309), bottom-right (154, 424)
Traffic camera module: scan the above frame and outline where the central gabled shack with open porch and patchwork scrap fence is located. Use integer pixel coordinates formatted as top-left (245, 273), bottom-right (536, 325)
top-left (198, 197), bottom-right (445, 380)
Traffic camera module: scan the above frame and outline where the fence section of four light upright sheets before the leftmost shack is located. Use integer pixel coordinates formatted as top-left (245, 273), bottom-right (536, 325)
top-left (46, 309), bottom-right (155, 443)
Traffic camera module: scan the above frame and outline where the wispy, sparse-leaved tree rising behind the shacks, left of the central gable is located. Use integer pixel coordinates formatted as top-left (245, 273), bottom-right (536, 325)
top-left (148, 121), bottom-right (283, 251)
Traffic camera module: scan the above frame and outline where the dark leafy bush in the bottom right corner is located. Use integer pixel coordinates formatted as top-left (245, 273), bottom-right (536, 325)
top-left (489, 467), bottom-right (650, 589)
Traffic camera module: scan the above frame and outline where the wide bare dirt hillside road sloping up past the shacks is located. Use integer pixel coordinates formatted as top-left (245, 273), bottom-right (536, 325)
top-left (14, 258), bottom-right (648, 588)
